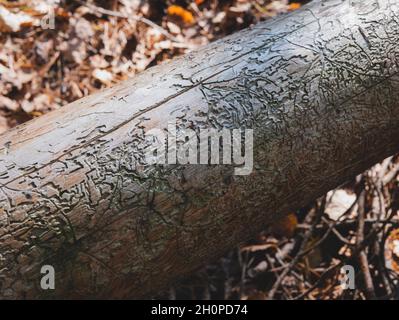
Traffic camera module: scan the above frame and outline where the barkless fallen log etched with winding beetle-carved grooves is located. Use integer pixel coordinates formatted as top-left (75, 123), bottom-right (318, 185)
top-left (0, 0), bottom-right (399, 298)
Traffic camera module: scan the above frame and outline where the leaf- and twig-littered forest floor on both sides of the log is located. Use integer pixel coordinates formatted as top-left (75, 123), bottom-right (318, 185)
top-left (0, 0), bottom-right (399, 299)
